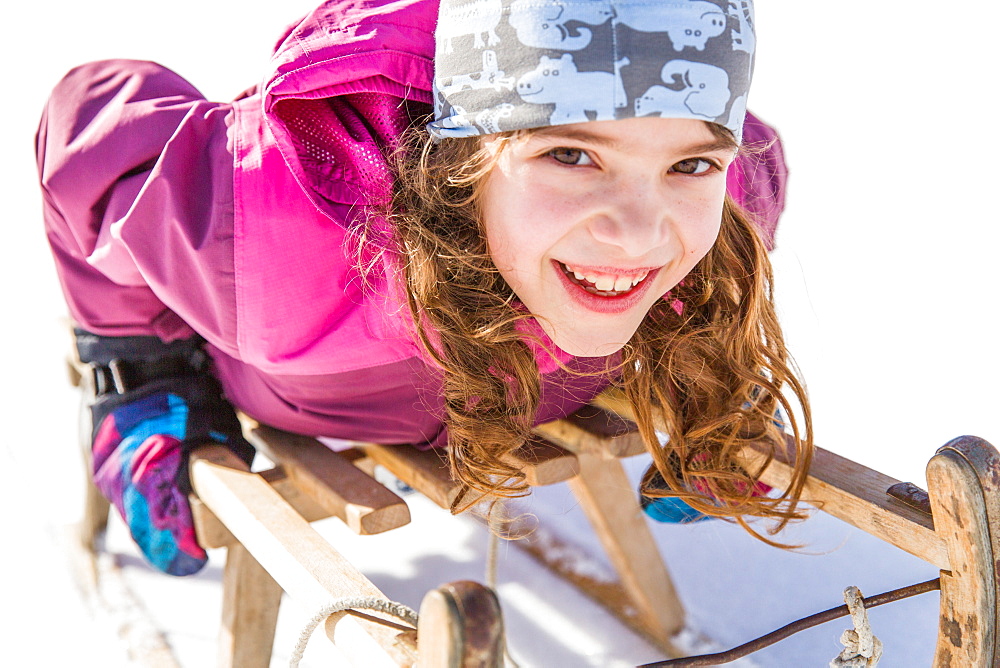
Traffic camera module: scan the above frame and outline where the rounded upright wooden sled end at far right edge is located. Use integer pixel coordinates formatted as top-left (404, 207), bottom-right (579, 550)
top-left (927, 436), bottom-right (1000, 668)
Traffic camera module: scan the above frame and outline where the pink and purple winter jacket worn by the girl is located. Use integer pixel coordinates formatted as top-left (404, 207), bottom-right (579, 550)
top-left (37, 0), bottom-right (785, 445)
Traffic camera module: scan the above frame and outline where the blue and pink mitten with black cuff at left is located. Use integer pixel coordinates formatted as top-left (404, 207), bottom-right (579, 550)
top-left (78, 333), bottom-right (253, 575)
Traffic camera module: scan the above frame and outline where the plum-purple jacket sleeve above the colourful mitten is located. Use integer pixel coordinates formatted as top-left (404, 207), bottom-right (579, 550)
top-left (36, 60), bottom-right (244, 354)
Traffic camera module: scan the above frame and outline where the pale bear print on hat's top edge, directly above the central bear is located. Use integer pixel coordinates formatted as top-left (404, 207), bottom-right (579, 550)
top-left (510, 0), bottom-right (614, 51)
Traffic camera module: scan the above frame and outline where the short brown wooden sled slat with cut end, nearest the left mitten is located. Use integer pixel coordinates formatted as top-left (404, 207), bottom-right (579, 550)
top-left (244, 420), bottom-right (410, 535)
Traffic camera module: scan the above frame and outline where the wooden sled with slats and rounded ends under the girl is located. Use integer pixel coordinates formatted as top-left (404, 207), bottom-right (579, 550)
top-left (66, 352), bottom-right (1000, 668)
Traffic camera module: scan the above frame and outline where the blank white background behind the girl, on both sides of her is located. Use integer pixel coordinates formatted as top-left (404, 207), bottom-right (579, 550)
top-left (0, 0), bottom-right (1000, 665)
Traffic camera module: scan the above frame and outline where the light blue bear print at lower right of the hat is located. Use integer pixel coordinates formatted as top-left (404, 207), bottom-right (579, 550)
top-left (635, 60), bottom-right (731, 121)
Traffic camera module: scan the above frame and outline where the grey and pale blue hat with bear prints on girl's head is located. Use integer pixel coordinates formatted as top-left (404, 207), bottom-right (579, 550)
top-left (427, 0), bottom-right (756, 141)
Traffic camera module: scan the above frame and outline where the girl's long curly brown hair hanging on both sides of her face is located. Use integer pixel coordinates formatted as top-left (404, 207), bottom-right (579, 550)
top-left (380, 123), bottom-right (812, 544)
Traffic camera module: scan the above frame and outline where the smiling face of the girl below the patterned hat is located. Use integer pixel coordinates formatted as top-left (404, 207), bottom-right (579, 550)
top-left (482, 117), bottom-right (735, 357)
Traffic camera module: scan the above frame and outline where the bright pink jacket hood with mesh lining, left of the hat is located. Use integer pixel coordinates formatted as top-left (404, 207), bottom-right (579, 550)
top-left (260, 0), bottom-right (438, 208)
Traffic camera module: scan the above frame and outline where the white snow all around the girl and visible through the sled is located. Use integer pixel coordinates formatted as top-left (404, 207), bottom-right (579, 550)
top-left (0, 0), bottom-right (1000, 668)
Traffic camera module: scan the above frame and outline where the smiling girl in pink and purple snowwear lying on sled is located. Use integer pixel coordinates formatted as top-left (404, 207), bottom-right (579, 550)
top-left (37, 0), bottom-right (811, 575)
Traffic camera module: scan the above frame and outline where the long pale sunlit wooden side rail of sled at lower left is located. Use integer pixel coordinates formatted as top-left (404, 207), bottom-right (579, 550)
top-left (191, 446), bottom-right (416, 666)
